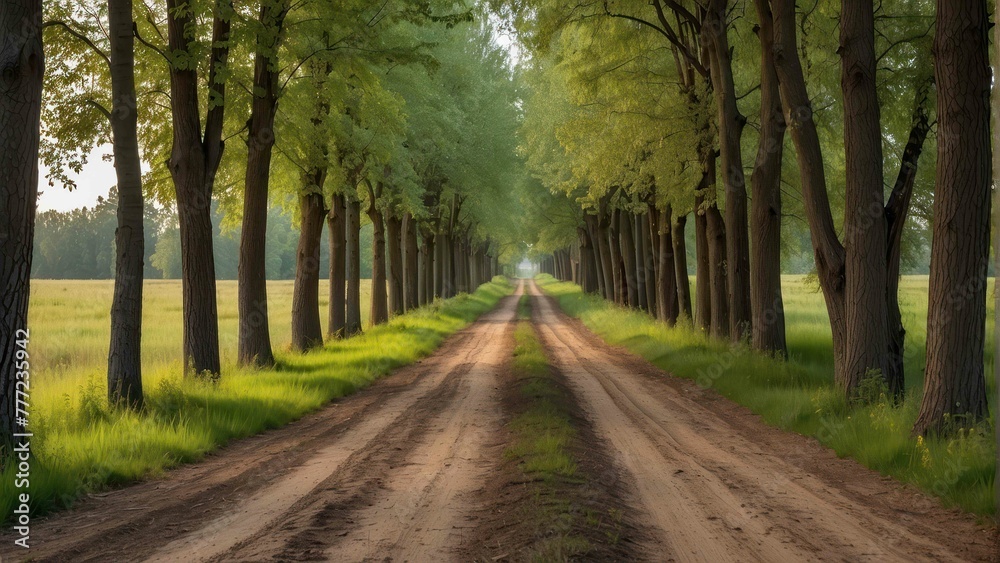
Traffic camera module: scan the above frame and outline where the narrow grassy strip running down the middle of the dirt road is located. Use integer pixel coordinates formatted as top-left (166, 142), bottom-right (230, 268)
top-left (504, 295), bottom-right (622, 561)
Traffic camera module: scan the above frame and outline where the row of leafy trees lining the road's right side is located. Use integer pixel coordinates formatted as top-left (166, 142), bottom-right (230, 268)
top-left (504, 0), bottom-right (991, 434)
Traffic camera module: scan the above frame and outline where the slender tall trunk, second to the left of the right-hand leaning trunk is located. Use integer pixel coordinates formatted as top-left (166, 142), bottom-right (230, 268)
top-left (704, 0), bottom-right (751, 342)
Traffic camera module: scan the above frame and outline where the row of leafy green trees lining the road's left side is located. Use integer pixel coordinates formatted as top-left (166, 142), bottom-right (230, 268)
top-left (0, 0), bottom-right (523, 454)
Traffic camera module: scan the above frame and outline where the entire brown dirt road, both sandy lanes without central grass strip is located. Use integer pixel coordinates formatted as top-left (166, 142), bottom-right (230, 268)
top-left (0, 282), bottom-right (997, 562)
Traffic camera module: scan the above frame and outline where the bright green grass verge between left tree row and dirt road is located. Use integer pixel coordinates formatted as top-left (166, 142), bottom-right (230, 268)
top-left (0, 278), bottom-right (512, 520)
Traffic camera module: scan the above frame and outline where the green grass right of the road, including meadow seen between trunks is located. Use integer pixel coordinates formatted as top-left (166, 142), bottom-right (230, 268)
top-left (538, 275), bottom-right (997, 515)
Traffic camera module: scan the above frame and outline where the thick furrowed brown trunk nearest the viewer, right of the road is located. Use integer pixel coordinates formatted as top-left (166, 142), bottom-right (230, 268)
top-left (913, 0), bottom-right (992, 434)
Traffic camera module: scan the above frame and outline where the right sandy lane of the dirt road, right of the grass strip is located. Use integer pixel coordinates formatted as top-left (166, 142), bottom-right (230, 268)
top-left (530, 282), bottom-right (995, 563)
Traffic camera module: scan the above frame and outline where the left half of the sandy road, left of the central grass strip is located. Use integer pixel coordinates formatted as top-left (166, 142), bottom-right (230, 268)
top-left (0, 282), bottom-right (521, 562)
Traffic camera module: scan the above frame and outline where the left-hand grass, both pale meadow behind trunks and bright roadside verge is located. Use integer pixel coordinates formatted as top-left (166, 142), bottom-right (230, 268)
top-left (0, 278), bottom-right (512, 518)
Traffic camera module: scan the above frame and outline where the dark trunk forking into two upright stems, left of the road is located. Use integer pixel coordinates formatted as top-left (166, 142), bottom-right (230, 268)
top-left (166, 0), bottom-right (233, 377)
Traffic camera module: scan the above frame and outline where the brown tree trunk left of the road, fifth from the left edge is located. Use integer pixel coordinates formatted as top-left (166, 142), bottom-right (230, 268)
top-left (292, 189), bottom-right (324, 352)
